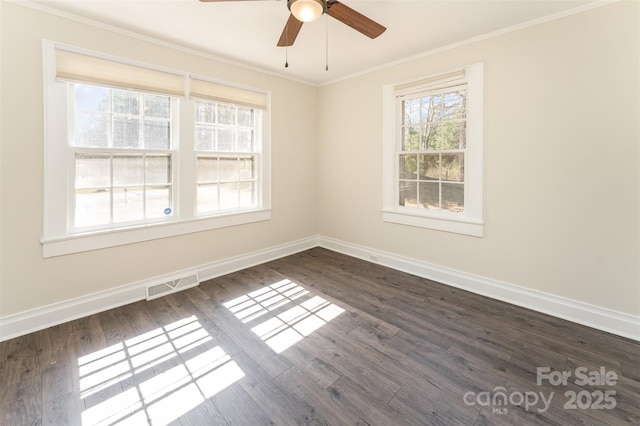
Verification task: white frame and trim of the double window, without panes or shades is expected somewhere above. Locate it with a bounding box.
[40,40,271,258]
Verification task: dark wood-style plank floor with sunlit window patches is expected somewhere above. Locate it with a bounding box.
[0,248,640,426]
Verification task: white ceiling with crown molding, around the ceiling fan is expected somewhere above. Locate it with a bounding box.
[22,0,601,85]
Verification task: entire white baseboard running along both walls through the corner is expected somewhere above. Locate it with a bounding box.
[0,236,640,341]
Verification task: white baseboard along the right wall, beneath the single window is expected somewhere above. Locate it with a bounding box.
[318,236,640,341]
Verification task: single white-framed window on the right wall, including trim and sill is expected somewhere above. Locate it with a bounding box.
[382,64,483,236]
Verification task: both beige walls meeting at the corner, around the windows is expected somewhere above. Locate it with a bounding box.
[0,2,640,317]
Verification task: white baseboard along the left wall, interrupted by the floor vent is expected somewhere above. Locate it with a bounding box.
[0,237,318,342]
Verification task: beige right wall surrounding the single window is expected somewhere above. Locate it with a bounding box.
[318,2,640,315]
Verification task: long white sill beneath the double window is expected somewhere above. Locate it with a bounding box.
[40,209,271,258]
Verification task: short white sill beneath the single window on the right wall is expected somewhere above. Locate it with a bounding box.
[382,210,484,237]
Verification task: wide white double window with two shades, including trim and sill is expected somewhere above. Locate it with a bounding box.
[42,42,271,257]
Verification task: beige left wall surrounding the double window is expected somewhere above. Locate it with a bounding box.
[0,2,317,317]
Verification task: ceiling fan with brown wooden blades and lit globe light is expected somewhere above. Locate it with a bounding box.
[200,0,386,47]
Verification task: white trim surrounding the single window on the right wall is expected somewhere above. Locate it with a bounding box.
[382,64,484,237]
